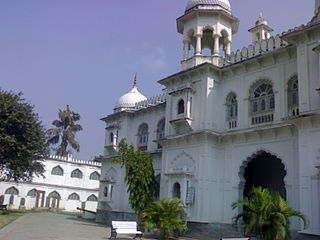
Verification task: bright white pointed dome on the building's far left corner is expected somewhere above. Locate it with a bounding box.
[115,85,147,109]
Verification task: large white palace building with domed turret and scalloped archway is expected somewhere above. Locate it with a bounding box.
[98,0,320,234]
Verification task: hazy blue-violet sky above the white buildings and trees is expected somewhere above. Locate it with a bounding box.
[0,0,314,159]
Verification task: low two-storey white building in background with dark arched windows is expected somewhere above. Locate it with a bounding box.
[0,155,101,211]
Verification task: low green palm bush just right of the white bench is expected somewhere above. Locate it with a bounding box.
[142,198,187,239]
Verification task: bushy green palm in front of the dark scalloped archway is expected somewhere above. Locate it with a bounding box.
[232,187,307,240]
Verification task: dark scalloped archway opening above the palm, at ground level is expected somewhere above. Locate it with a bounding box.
[243,152,286,200]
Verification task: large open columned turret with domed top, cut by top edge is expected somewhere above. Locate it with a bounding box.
[177,0,239,70]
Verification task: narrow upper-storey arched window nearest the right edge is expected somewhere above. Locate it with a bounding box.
[288,75,299,116]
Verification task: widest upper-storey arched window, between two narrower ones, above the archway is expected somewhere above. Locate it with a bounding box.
[250,82,275,124]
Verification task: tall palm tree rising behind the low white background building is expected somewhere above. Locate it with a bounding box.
[47,105,82,156]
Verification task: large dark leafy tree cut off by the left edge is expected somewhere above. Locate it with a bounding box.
[0,89,47,181]
